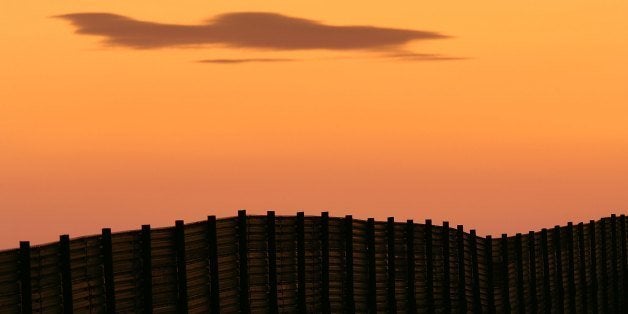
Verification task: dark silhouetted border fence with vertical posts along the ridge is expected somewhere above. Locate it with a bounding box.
[0,211,628,313]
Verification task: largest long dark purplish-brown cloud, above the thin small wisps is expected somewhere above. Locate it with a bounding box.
[58,12,447,50]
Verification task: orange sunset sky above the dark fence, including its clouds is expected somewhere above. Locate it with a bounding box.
[0,0,628,248]
